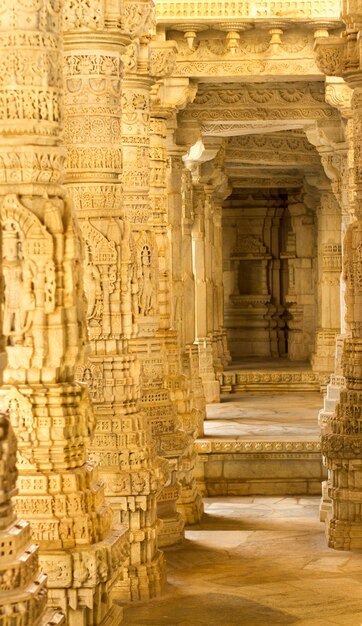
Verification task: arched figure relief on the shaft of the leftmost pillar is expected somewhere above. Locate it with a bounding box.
[1,195,56,369]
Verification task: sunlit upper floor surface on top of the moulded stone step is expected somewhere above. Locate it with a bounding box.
[204,392,323,441]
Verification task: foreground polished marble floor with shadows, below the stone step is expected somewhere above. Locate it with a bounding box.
[122,497,362,626]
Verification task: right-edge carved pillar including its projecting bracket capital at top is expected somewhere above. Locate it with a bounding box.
[316,29,362,550]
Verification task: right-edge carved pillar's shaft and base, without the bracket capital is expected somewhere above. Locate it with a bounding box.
[322,81,362,550]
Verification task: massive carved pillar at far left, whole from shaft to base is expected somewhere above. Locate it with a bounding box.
[0,0,128,626]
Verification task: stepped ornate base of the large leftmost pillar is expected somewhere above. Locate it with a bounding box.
[1,383,129,626]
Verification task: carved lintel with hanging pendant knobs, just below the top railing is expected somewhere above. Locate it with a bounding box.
[167,26,328,82]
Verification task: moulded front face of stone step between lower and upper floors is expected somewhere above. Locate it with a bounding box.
[195,438,326,496]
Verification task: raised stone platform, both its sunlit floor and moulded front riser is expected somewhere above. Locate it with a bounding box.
[196,393,326,496]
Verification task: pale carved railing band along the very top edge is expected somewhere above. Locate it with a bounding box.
[156,0,341,23]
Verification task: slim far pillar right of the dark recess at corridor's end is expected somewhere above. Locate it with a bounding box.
[312,189,342,375]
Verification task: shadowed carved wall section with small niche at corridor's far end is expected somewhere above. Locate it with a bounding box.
[223,189,285,359]
